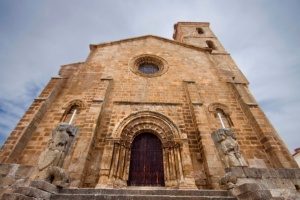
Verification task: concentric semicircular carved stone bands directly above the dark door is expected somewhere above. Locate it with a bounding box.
[112,111,181,143]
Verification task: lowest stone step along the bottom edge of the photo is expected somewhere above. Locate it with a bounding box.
[51,194,237,200]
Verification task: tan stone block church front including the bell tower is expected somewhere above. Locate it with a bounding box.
[0,22,298,200]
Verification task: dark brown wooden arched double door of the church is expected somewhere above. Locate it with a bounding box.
[128,133,165,186]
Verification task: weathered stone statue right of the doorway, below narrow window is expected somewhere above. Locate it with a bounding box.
[212,128,247,168]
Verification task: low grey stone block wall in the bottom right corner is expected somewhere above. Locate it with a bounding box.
[227,167,300,200]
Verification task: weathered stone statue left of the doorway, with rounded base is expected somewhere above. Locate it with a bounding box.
[35,123,74,187]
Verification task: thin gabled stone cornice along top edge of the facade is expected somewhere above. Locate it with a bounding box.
[90,35,212,53]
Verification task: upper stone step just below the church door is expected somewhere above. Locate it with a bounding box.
[60,188,232,197]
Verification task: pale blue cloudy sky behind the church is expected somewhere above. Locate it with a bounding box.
[0,0,300,153]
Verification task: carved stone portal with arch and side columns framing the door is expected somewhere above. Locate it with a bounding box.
[96,111,196,188]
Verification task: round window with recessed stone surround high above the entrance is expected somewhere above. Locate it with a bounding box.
[129,55,168,77]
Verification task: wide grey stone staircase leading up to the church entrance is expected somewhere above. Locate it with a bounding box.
[51,187,237,200]
